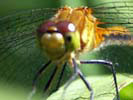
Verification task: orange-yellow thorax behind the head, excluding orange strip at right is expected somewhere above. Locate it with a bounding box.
[54,7,96,51]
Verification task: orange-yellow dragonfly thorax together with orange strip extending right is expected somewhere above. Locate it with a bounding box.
[53,7,129,52]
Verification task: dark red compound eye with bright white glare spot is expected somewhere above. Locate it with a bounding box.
[57,21,75,34]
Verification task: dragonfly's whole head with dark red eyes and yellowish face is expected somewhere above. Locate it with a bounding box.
[37,21,80,59]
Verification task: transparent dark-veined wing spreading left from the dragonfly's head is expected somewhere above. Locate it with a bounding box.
[0,9,55,59]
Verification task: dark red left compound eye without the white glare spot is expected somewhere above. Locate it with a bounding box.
[37,20,55,37]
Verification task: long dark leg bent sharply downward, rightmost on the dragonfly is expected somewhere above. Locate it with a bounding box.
[80,60,120,100]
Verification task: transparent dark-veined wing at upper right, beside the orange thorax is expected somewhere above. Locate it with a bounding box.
[92,0,133,33]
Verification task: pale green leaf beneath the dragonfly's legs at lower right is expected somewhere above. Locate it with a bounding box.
[47,74,133,100]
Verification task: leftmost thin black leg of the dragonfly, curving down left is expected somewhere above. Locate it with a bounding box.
[32,61,51,89]
